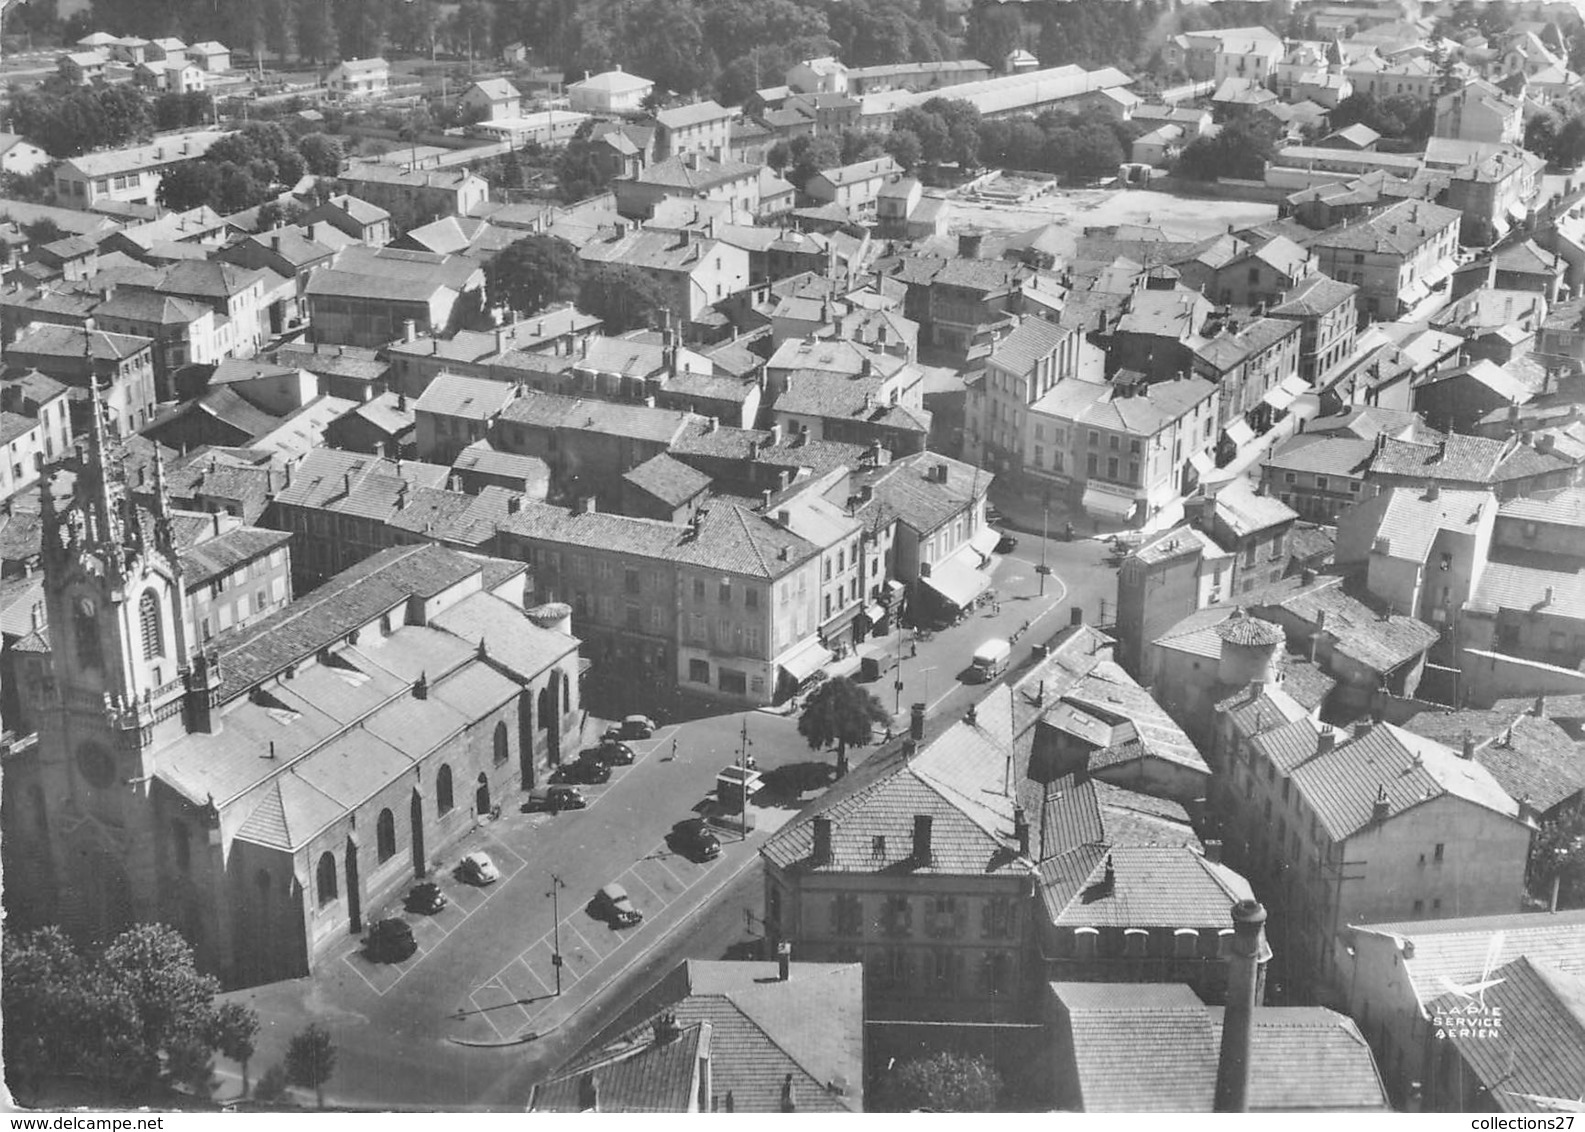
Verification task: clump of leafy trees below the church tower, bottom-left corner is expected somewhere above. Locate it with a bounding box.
[0,924,257,1100]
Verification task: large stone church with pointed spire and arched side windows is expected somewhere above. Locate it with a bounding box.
[0,388,580,986]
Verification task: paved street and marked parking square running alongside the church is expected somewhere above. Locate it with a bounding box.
[216,536,1116,1110]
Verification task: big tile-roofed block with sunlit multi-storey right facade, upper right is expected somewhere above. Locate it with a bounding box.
[1311,201,1460,319]
